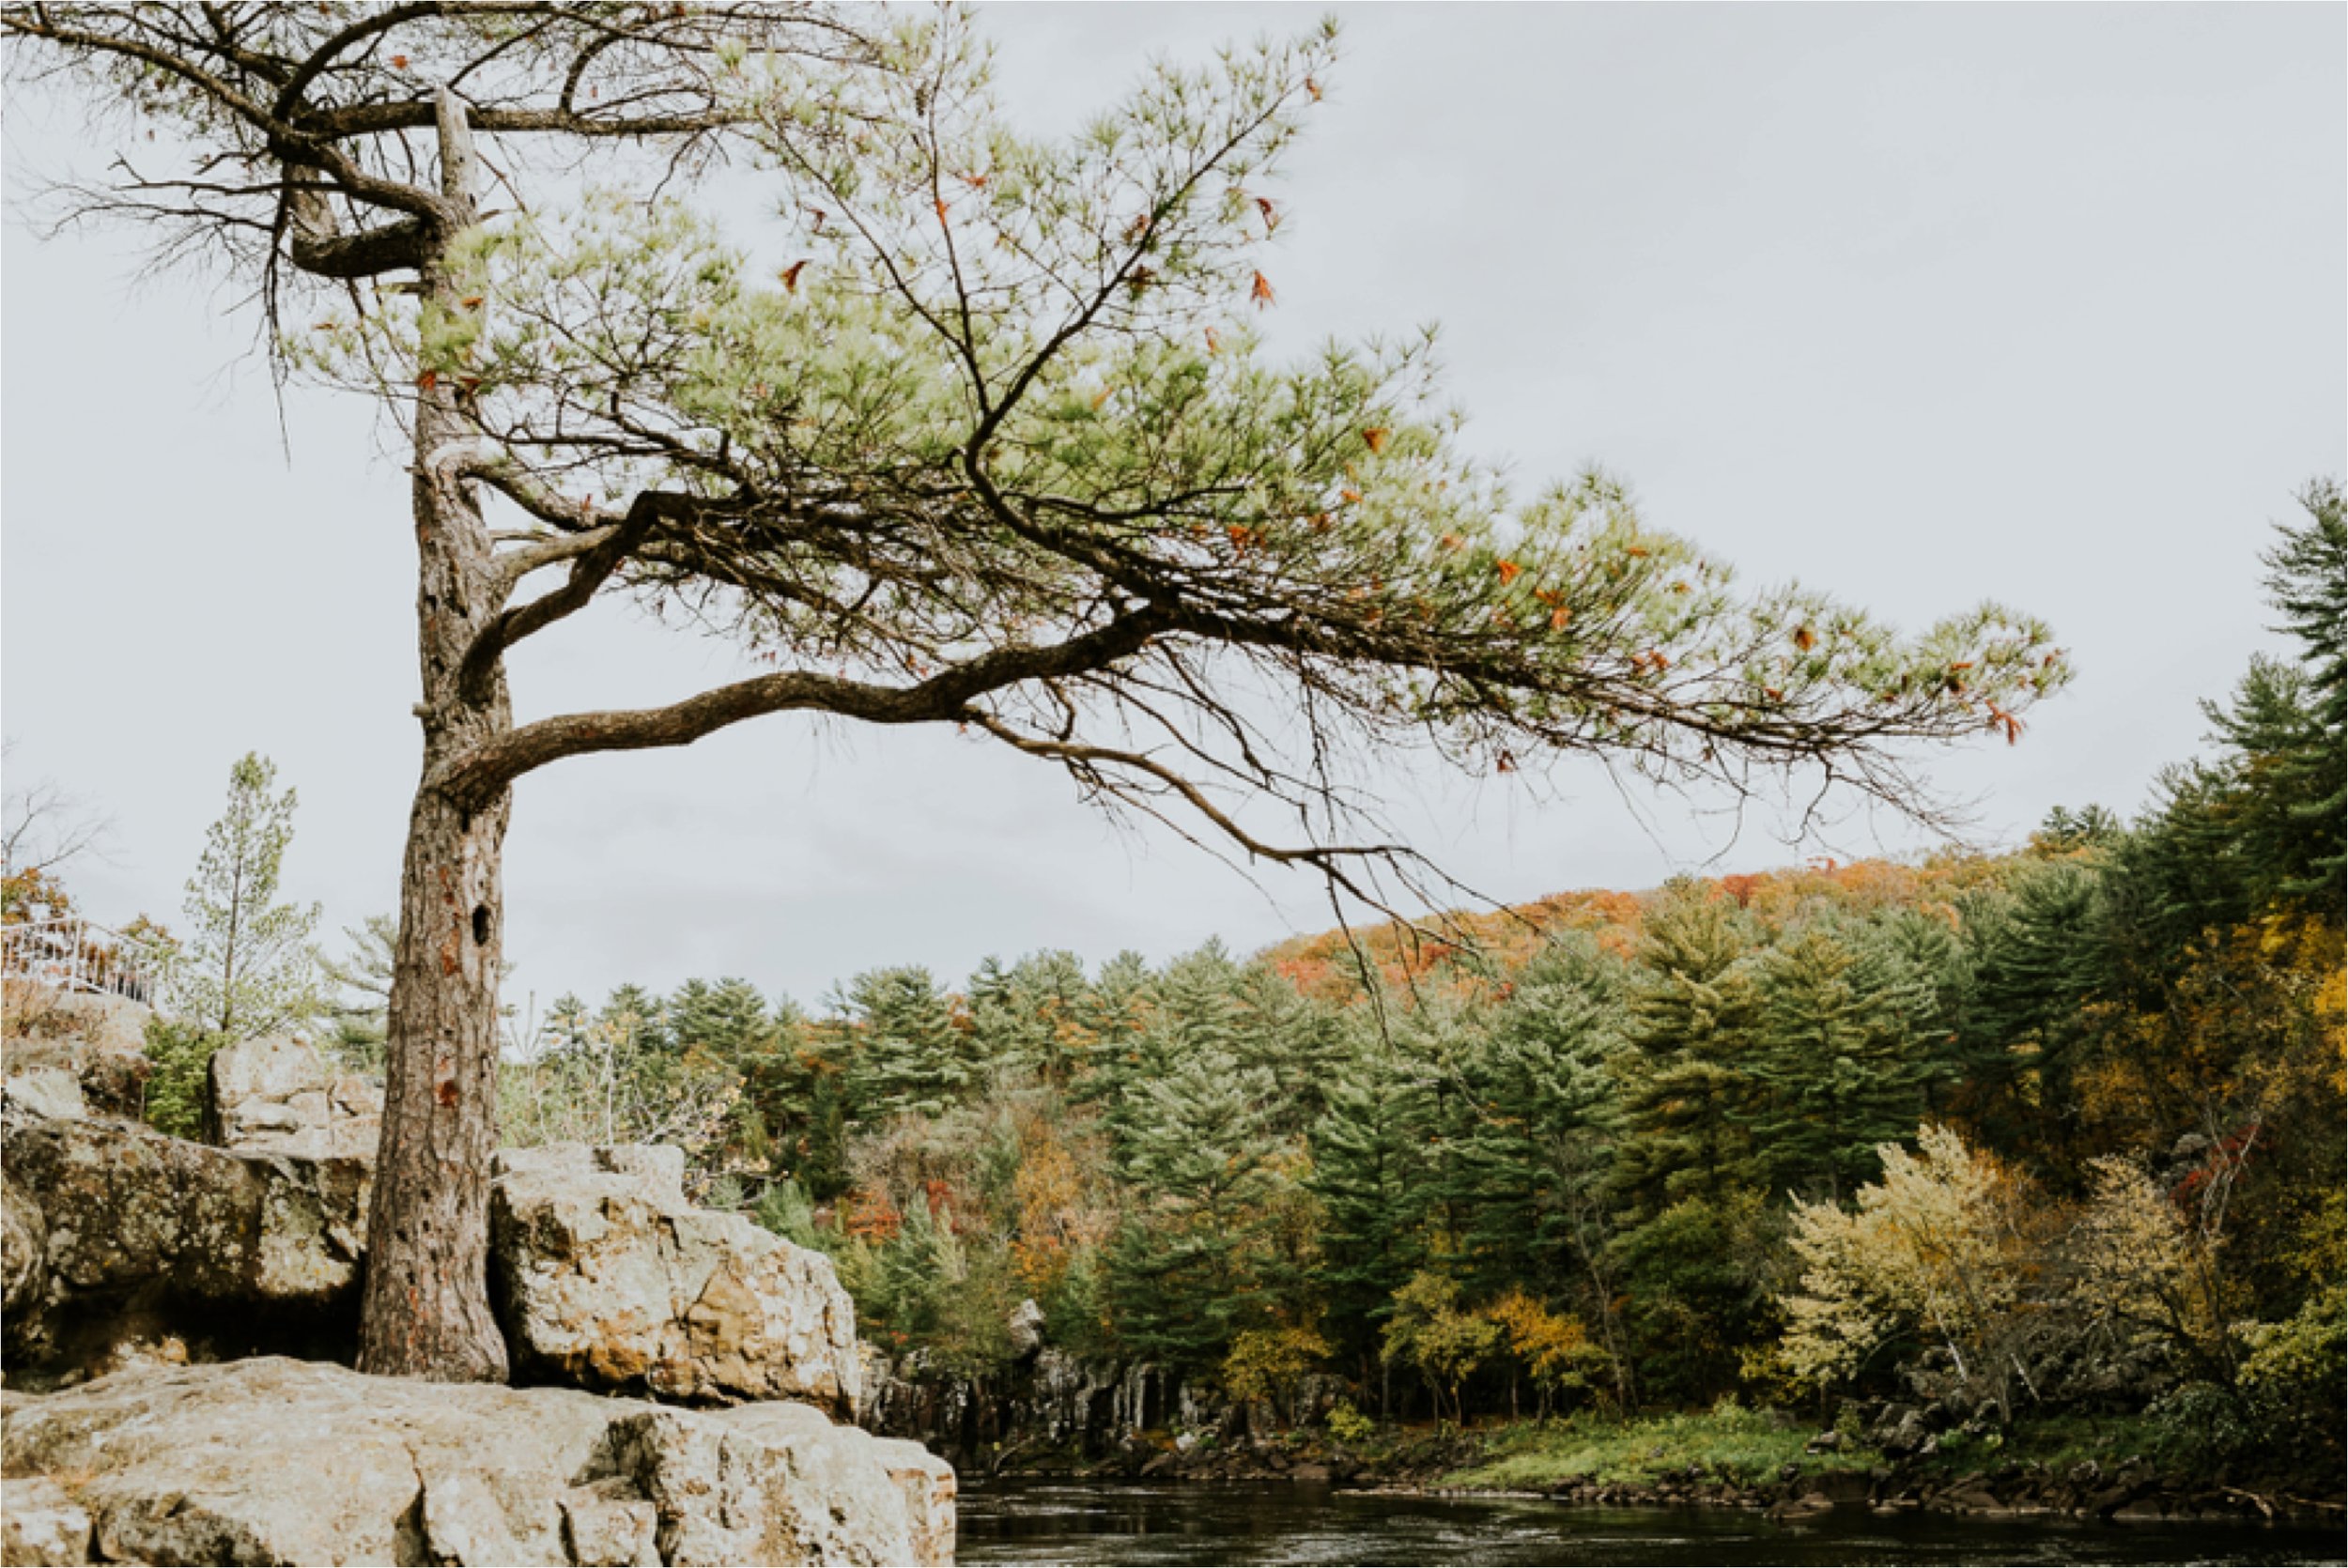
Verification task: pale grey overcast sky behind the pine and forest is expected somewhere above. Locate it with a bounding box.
[0,5,2348,1003]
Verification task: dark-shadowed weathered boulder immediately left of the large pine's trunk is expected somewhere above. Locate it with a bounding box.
[0,1108,369,1388]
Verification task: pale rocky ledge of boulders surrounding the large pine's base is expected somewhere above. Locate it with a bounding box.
[0,1000,956,1563]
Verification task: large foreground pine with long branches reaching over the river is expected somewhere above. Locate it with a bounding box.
[13,0,2064,1378]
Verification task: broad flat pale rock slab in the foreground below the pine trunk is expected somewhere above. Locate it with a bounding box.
[0,1360,956,1563]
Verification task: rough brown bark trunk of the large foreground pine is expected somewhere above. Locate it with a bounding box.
[360,94,515,1383]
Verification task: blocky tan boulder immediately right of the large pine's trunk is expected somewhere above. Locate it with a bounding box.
[488,1144,862,1421]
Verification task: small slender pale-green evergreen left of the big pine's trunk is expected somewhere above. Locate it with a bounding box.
[172,754,319,1045]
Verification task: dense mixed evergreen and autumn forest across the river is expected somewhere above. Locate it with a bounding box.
[448,482,2348,1477]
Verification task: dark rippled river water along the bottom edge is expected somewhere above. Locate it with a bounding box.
[958,1482,2343,1568]
